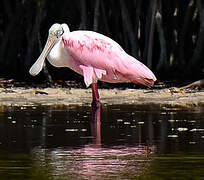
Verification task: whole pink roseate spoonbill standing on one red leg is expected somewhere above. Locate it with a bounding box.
[29,24,156,102]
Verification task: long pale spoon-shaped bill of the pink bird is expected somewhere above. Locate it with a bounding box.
[29,36,56,76]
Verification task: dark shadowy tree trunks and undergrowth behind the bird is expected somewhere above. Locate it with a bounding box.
[0,0,204,84]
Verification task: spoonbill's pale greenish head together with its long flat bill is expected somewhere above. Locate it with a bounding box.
[29,23,70,76]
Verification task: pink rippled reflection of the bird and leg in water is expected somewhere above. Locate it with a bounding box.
[25,105,155,179]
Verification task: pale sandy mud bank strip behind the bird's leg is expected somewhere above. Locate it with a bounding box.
[0,88,204,108]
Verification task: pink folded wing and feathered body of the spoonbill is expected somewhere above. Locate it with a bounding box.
[63,31,156,86]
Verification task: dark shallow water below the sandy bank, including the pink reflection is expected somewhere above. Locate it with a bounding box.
[0,105,204,180]
